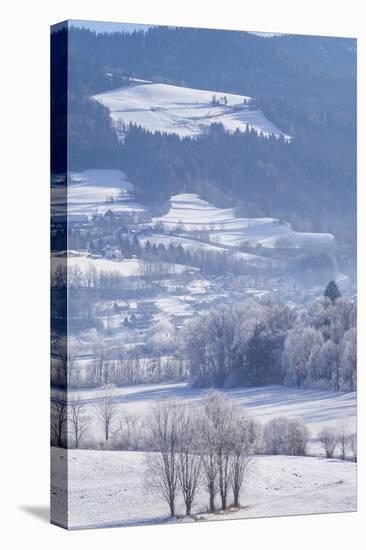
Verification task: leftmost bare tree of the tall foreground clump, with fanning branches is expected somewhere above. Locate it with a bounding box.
[146,401,179,517]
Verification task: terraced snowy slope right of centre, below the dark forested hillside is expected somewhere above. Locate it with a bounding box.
[153,193,334,248]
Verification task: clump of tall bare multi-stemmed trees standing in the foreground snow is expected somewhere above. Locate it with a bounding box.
[147,392,259,516]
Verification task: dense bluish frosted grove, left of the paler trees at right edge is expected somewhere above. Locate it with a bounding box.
[182,299,297,387]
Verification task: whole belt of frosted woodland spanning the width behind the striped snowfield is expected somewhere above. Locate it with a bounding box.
[52,282,357,391]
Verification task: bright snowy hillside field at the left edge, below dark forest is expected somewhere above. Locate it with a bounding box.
[52,169,145,215]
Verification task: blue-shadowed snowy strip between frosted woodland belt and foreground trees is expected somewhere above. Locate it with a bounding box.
[53,384,356,453]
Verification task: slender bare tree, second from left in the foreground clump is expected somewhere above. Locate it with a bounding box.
[178,406,201,516]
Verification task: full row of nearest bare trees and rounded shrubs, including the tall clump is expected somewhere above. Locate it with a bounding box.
[51,390,357,468]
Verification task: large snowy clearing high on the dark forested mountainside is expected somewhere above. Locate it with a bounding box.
[93,83,290,140]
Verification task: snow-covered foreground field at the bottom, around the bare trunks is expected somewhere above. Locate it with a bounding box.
[52,448,356,528]
